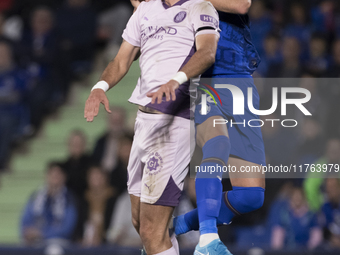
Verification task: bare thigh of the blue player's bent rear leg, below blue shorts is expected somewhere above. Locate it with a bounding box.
[228,157,266,188]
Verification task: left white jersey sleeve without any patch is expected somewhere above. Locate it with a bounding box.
[122,4,142,47]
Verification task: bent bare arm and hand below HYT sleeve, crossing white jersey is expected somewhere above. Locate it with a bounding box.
[147,34,219,104]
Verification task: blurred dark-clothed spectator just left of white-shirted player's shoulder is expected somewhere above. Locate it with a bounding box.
[95,0,133,61]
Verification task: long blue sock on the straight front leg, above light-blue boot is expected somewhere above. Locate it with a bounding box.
[196,136,231,235]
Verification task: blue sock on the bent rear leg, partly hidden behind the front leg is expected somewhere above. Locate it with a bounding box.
[174,187,265,235]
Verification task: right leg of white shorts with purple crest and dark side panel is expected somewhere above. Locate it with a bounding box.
[141,113,195,206]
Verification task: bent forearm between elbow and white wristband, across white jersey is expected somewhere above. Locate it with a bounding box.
[180,48,216,79]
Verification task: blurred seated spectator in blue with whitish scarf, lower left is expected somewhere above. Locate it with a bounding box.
[21,163,77,245]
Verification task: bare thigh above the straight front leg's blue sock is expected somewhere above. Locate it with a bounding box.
[196,116,229,148]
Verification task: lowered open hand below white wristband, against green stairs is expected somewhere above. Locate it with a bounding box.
[84,89,111,122]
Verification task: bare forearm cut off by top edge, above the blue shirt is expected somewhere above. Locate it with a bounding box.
[209,0,251,14]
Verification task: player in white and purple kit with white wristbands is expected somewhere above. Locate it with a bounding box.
[84,0,219,255]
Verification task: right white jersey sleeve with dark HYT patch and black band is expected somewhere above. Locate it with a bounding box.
[191,1,221,36]
